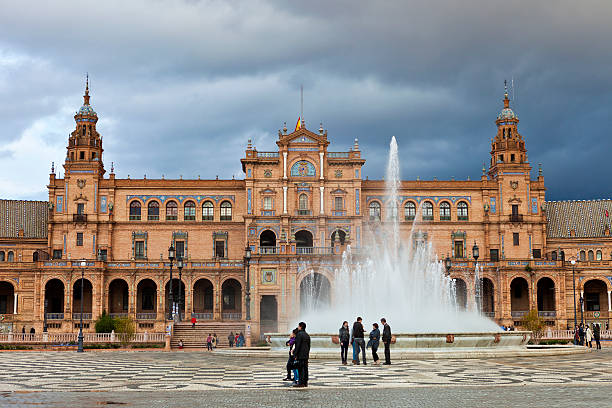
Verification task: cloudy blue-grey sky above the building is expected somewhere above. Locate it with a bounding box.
[0,0,612,200]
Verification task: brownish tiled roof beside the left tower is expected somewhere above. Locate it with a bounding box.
[0,200,49,238]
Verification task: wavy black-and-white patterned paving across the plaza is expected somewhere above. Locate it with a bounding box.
[0,350,612,391]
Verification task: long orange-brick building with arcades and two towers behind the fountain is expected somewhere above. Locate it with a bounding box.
[0,83,612,336]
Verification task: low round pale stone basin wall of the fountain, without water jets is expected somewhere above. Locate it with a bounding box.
[265,331,531,359]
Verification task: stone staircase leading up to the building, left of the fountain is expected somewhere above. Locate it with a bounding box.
[170,322,246,349]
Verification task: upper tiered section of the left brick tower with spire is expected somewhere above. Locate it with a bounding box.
[64,77,105,176]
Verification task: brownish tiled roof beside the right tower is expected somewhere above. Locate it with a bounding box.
[546,200,612,238]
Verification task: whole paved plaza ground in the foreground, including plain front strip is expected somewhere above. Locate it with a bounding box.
[0,350,612,408]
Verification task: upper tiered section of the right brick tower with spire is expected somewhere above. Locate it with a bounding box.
[489,81,531,178]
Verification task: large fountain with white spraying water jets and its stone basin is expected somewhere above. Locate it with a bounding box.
[269,137,530,353]
